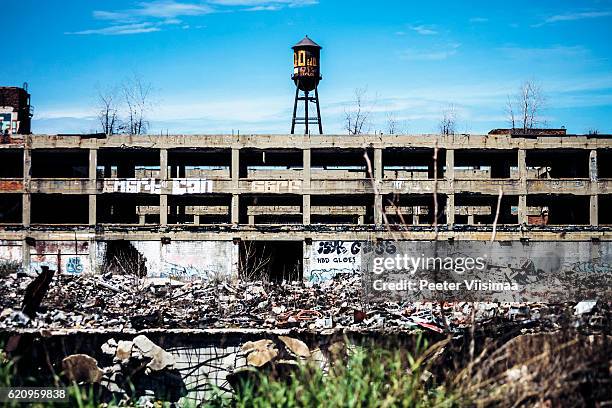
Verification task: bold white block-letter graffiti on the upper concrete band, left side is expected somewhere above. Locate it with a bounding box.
[102,178,213,195]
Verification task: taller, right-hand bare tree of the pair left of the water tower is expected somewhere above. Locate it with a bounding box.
[121,75,152,135]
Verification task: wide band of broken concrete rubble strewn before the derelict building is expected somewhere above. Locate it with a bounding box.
[0,273,610,333]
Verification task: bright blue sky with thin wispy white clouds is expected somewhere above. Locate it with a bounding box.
[0,0,612,133]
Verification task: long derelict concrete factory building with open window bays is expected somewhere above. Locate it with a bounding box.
[0,131,612,279]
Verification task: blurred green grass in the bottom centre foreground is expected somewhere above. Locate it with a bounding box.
[209,336,461,408]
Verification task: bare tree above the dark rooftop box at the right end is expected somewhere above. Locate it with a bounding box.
[506,81,545,133]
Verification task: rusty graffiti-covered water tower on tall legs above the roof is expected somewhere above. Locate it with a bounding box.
[291,36,323,134]
